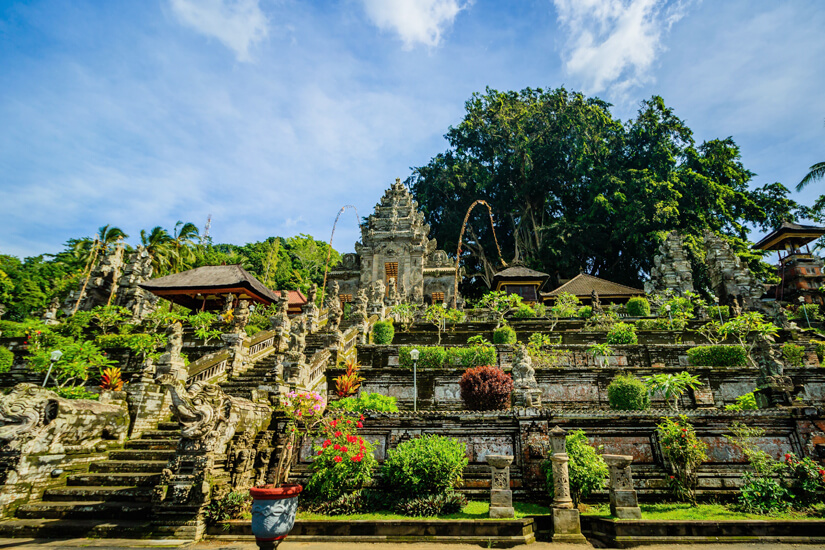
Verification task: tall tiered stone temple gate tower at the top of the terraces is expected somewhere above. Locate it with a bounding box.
[329,179,455,303]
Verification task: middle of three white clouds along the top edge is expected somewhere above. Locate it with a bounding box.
[361,0,473,49]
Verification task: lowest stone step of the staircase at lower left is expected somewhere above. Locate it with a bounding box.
[0,519,151,539]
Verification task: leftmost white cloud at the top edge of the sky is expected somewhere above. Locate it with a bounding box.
[170,0,268,61]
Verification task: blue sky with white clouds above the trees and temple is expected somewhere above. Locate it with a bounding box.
[0,0,825,257]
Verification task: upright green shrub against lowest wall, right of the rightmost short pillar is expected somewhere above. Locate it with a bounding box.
[656,416,708,503]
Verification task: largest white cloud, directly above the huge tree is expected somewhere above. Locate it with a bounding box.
[553,0,686,95]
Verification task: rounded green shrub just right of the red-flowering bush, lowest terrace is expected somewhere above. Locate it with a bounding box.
[382,435,468,498]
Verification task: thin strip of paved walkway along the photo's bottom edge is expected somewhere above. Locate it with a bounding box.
[0,539,819,550]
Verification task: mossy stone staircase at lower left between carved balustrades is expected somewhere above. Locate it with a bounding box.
[0,422,180,538]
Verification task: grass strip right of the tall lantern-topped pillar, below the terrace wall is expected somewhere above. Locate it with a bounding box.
[582,503,825,521]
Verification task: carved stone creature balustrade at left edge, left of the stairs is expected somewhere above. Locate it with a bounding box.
[0,384,129,458]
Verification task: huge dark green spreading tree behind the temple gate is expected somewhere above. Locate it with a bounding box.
[408,88,798,294]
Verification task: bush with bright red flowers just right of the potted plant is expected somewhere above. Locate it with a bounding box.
[306,416,378,501]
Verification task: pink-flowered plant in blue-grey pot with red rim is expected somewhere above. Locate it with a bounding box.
[249,391,326,550]
